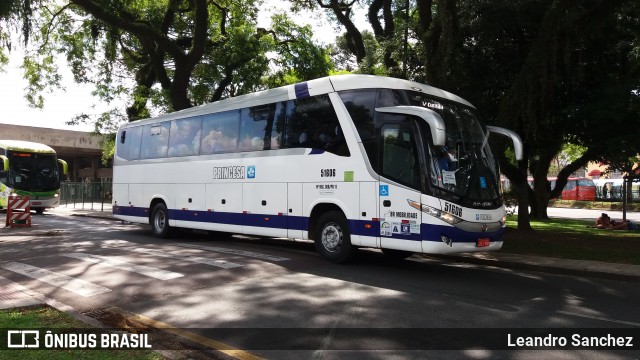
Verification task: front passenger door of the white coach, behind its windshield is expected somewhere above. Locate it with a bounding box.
[378,122,422,252]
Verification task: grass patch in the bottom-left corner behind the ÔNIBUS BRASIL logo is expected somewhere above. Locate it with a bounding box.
[0,306,163,360]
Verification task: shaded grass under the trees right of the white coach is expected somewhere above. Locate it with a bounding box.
[502,215,640,265]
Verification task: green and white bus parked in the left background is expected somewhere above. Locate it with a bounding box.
[0,140,68,214]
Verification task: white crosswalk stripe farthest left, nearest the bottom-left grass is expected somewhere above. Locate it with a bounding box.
[2,262,111,297]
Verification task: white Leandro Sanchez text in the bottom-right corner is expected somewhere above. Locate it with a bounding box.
[507,333,635,349]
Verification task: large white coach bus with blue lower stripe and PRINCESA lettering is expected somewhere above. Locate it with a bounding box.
[113,75,522,262]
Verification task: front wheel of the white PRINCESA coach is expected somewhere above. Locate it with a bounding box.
[315,211,355,264]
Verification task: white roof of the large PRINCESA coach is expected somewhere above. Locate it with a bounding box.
[122,74,473,128]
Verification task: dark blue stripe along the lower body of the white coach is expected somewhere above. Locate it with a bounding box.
[113,206,505,243]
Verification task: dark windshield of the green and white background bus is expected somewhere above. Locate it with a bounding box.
[7,150,60,191]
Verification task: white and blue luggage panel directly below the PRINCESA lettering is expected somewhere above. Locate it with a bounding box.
[205,183,242,233]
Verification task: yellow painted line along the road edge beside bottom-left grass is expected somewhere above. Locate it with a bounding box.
[106,307,263,360]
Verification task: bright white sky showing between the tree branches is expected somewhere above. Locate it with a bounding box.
[0,0,368,132]
